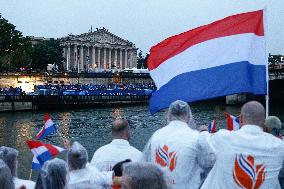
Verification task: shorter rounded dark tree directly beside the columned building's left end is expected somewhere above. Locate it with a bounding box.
[31,39,64,71]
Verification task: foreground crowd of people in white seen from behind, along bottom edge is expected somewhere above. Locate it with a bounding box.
[0,100,284,189]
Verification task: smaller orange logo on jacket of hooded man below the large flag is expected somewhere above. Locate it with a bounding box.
[156,145,177,171]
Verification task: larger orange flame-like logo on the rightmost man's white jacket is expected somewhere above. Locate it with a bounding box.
[233,154,265,189]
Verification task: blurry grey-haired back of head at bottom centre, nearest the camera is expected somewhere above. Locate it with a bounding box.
[121,162,167,189]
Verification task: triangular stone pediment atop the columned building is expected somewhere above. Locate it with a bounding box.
[62,28,135,47]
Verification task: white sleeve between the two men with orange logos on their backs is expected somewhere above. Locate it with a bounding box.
[197,131,216,169]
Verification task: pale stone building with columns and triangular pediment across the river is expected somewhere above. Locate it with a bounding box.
[60,28,137,73]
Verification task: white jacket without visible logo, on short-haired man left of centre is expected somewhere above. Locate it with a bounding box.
[90,139,141,171]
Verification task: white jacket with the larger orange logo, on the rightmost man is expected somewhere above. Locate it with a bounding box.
[201,125,284,189]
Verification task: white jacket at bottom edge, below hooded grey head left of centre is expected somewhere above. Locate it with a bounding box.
[69,166,113,189]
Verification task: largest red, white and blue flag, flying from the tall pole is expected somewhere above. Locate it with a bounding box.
[147,10,268,114]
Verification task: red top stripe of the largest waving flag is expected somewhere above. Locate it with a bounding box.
[147,10,264,70]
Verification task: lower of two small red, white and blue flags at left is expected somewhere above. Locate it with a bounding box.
[26,140,64,169]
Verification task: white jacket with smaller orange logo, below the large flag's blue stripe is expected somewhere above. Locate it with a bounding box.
[143,121,204,189]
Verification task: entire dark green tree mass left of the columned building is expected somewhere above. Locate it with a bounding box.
[0,14,64,71]
